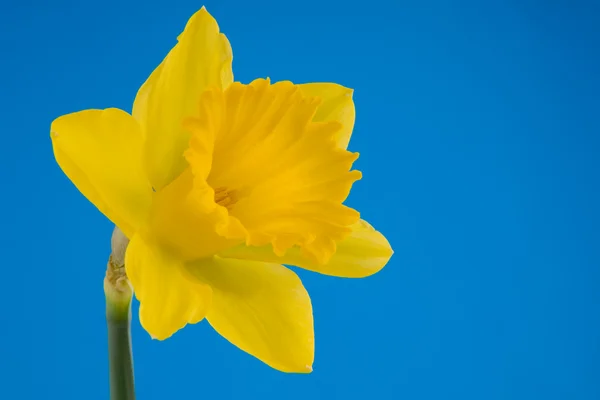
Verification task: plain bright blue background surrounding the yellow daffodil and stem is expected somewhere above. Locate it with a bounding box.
[0,0,600,400]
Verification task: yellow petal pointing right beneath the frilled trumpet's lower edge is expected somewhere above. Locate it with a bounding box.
[220,220,394,278]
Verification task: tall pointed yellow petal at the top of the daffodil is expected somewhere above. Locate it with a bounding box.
[133,8,233,190]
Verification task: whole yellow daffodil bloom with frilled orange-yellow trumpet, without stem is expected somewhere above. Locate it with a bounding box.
[51,8,392,372]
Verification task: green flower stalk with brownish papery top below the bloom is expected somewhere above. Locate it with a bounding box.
[104,228,135,400]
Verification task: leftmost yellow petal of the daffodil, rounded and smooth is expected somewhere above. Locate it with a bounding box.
[50,108,152,237]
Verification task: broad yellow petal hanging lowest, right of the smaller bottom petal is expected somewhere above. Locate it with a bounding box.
[188,257,315,372]
